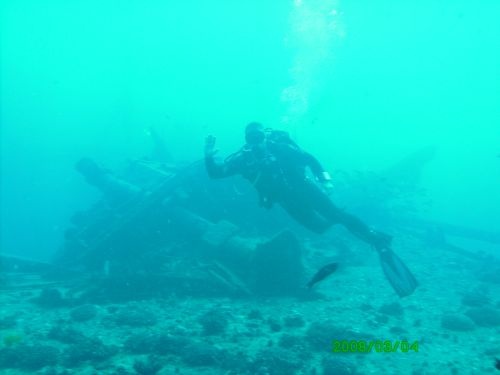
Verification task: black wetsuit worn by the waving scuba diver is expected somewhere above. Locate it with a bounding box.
[205,131,381,246]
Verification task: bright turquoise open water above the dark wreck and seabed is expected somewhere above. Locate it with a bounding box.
[0,0,500,374]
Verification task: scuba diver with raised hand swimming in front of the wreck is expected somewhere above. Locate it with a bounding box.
[205,122,418,297]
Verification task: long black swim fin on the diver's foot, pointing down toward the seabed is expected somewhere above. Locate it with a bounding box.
[378,249,418,297]
